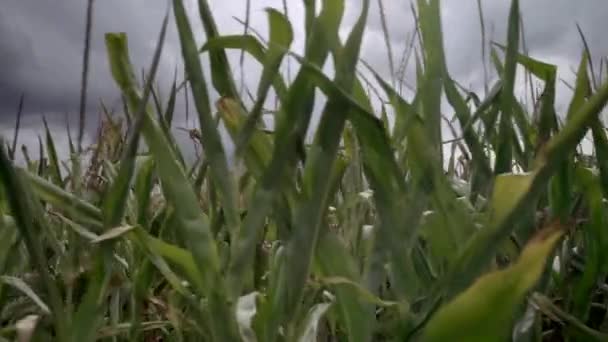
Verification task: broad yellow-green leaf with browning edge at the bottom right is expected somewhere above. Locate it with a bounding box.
[422,225,563,342]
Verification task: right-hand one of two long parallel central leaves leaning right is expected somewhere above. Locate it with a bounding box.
[277,1,369,320]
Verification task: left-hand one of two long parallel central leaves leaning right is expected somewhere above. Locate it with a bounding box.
[228,0,344,304]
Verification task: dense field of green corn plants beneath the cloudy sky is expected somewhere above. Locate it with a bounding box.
[0,0,608,342]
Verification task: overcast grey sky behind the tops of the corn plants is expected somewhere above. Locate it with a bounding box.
[0,0,608,161]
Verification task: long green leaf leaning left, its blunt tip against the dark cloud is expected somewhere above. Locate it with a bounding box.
[106,30,236,340]
